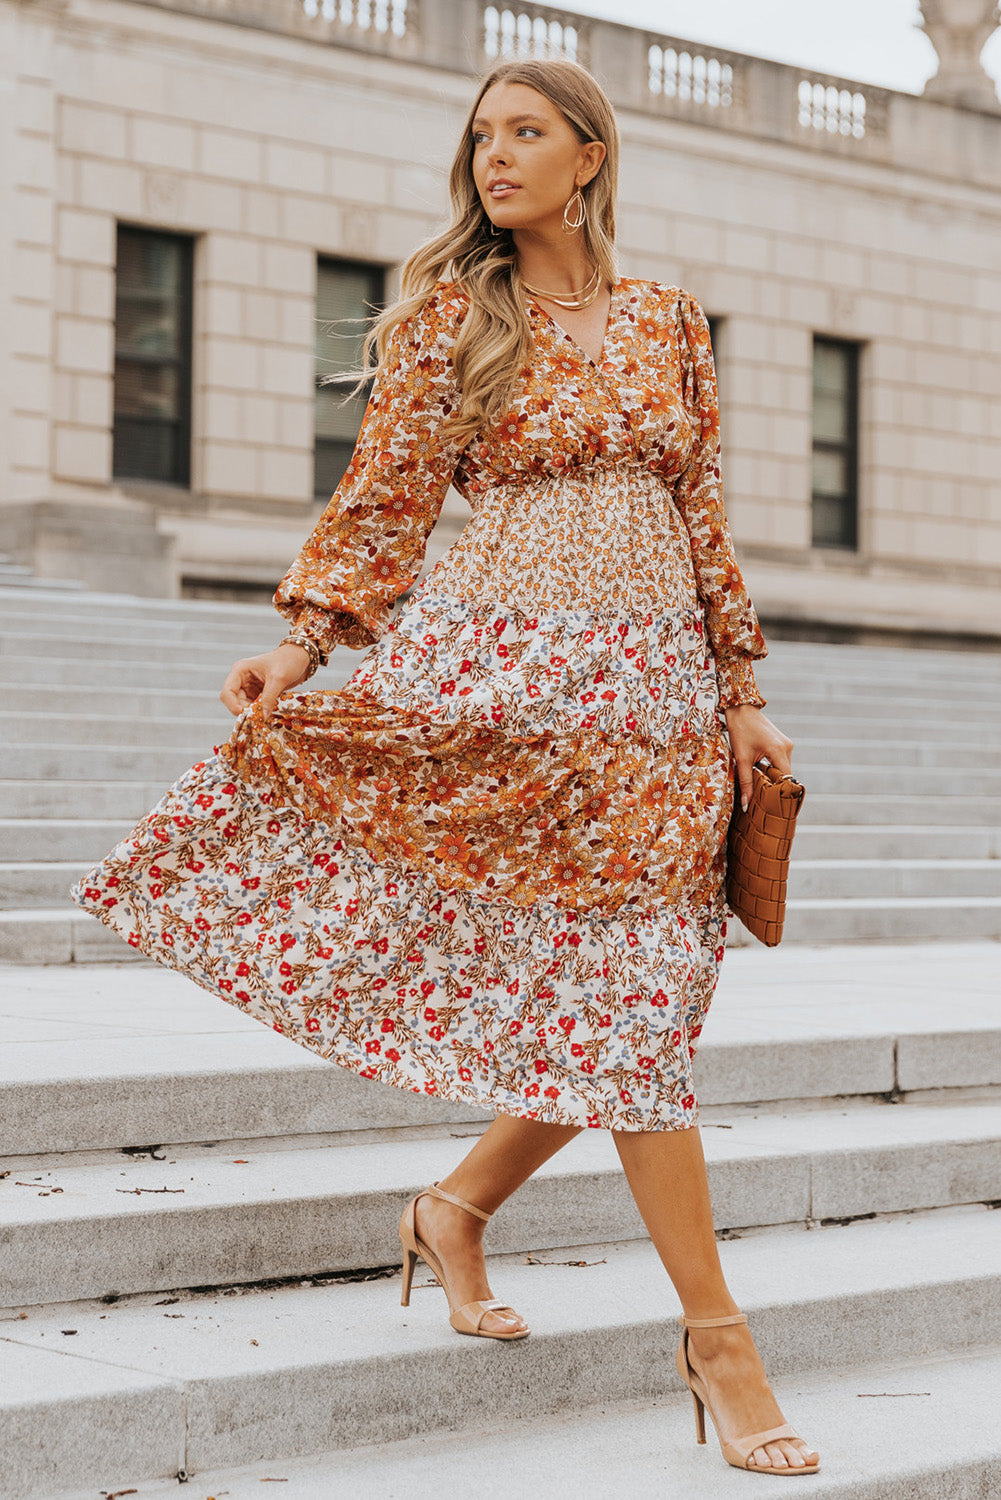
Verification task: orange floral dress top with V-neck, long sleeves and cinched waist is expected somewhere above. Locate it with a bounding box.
[275,279,767,707]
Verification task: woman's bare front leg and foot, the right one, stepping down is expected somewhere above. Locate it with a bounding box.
[612,1128,818,1469]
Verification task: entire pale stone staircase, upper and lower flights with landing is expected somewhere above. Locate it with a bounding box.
[0,587,1001,1500]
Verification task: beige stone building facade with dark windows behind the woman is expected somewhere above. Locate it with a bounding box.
[0,0,1001,645]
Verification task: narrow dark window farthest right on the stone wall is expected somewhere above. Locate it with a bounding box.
[812,338,858,548]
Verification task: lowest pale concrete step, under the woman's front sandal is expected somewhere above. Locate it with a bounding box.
[78,1349,1001,1500]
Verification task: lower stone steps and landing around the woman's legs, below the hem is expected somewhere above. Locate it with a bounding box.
[0,942,1001,1500]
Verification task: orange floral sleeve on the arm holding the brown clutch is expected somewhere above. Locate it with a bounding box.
[674,291,768,708]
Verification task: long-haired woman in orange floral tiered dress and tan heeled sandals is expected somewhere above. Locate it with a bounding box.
[74,62,816,1475]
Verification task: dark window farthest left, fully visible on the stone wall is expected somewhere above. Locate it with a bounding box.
[114,225,192,485]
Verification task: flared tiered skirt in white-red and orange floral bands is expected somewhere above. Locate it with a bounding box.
[72,576,732,1131]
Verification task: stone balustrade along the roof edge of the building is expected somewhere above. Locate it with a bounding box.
[123,0,1001,189]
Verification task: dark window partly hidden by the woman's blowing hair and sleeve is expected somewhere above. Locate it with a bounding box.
[314,257,386,500]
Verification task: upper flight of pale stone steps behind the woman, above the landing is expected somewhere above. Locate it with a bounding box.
[0,584,1001,963]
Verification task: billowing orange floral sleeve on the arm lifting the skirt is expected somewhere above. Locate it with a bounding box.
[275,288,462,651]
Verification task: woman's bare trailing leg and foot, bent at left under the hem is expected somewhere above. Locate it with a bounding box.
[416,1115,579,1331]
